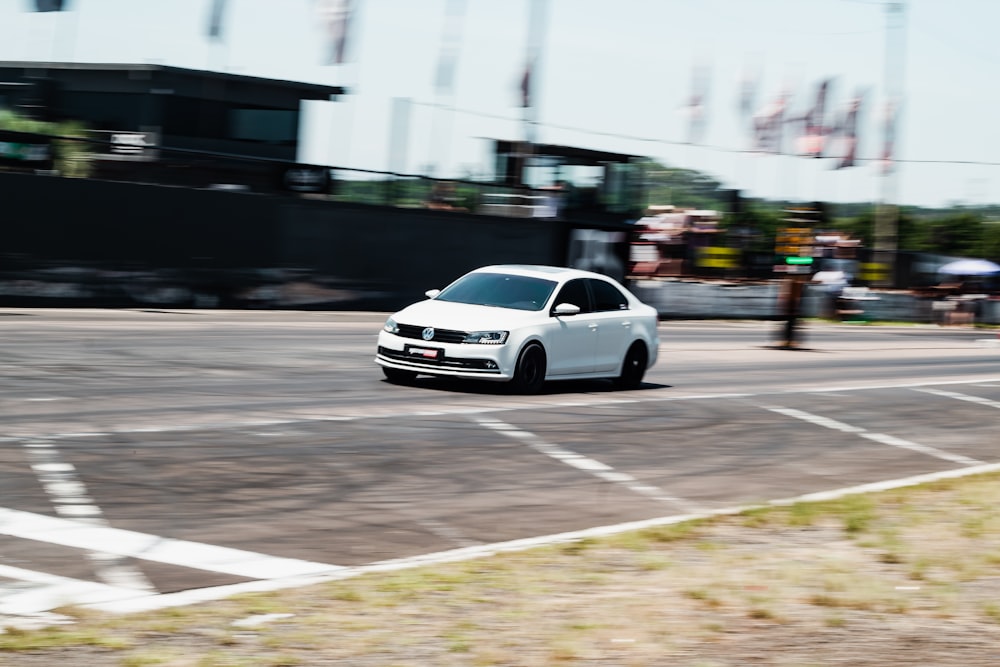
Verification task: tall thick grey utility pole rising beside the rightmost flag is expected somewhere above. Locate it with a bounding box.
[874,0,905,287]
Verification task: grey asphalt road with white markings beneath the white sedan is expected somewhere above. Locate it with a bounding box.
[0,310,1000,620]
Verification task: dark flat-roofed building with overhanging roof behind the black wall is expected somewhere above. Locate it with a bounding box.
[0,62,344,190]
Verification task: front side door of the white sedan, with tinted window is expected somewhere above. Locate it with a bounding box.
[545,279,597,375]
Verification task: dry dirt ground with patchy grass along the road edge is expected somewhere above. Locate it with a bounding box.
[0,475,1000,667]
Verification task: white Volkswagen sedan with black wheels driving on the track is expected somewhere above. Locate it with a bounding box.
[375,265,659,393]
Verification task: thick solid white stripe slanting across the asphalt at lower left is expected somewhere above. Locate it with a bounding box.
[0,508,341,579]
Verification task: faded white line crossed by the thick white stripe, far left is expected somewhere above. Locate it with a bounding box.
[21,439,155,591]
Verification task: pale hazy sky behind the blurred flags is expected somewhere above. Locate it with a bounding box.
[0,0,1000,207]
